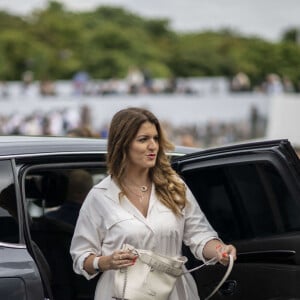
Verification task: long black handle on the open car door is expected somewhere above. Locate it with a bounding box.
[237,250,296,262]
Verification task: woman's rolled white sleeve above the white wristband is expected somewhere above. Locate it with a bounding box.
[70,192,104,279]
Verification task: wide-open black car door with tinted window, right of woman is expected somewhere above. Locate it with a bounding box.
[173,140,300,300]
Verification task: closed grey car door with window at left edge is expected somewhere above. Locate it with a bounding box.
[0,160,44,300]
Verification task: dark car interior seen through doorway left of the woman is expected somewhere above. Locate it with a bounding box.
[25,167,105,300]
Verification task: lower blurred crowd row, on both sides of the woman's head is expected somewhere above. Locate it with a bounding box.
[0,105,266,147]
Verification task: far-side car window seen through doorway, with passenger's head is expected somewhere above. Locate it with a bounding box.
[25,166,106,219]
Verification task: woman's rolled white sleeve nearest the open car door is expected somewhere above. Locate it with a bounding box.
[183,187,220,262]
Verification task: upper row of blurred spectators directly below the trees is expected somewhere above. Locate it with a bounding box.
[0,67,300,98]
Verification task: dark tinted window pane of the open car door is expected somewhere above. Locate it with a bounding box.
[185,162,300,241]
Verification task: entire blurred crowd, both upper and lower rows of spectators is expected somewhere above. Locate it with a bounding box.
[0,67,278,147]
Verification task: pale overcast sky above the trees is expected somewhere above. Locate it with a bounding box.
[0,0,300,41]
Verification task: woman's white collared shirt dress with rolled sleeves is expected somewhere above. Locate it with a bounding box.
[70,176,218,300]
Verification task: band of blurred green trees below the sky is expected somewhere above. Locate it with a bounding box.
[0,1,300,89]
